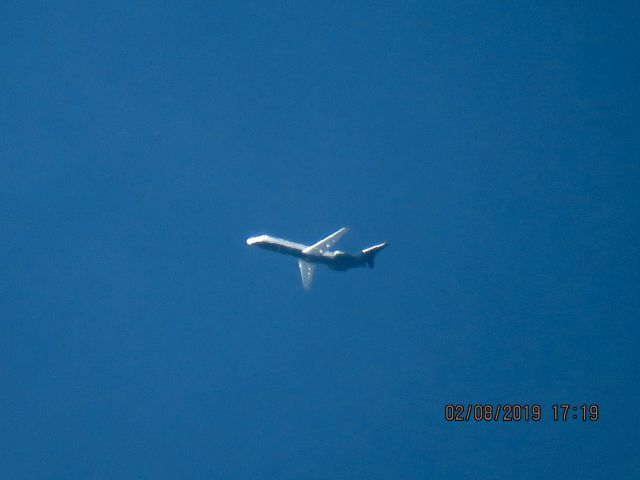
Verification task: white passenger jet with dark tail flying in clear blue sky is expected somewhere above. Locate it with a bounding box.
[247,228,389,290]
